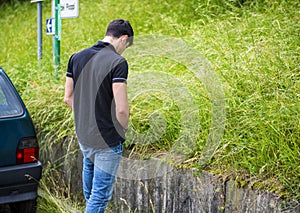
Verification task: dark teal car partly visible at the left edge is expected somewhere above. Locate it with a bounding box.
[0,68,42,213]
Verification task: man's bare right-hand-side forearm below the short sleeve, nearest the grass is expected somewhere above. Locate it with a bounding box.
[112,82,129,131]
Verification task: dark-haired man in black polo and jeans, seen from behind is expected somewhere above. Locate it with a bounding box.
[64,19,134,213]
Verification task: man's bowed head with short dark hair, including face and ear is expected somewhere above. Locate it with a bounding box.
[105,19,134,54]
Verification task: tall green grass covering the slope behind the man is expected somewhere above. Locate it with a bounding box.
[0,0,300,211]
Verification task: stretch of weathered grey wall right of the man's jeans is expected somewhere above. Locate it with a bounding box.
[113,169,300,213]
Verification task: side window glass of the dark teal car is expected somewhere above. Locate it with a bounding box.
[0,74,23,118]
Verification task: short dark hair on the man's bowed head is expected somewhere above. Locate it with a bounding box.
[105,19,134,46]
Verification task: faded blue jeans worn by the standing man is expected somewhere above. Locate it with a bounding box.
[80,144,123,213]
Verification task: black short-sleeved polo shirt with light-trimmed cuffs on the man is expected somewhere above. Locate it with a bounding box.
[67,41,128,148]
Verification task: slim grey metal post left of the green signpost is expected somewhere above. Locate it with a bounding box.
[31,0,43,61]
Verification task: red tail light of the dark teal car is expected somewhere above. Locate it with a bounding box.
[16,137,39,164]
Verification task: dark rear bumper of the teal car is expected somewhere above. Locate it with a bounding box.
[0,162,42,204]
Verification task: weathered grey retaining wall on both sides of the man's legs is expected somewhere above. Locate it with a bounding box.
[42,141,300,213]
